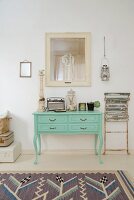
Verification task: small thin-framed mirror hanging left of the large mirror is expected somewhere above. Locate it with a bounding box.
[20,61,32,78]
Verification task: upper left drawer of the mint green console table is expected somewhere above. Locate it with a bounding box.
[38,115,67,124]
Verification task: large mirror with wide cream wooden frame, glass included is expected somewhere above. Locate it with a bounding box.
[46,33,91,86]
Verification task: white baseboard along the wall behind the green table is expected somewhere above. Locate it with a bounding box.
[22,149,134,155]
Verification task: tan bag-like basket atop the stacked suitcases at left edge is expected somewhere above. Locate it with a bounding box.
[0,117,10,134]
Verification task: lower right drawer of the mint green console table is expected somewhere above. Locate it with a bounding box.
[69,123,99,133]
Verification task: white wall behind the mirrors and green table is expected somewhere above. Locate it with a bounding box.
[0,0,134,152]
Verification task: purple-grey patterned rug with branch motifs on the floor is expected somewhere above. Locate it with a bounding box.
[0,171,134,200]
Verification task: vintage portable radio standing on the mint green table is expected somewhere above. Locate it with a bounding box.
[47,97,65,111]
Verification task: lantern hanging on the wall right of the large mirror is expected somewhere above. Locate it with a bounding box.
[101,36,110,81]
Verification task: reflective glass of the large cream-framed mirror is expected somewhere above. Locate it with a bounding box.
[50,38,85,82]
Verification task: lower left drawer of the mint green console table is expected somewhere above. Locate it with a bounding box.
[38,124,67,133]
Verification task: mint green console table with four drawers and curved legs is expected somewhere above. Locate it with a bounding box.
[33,111,103,164]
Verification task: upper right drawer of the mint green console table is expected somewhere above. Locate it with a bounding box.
[69,115,100,123]
